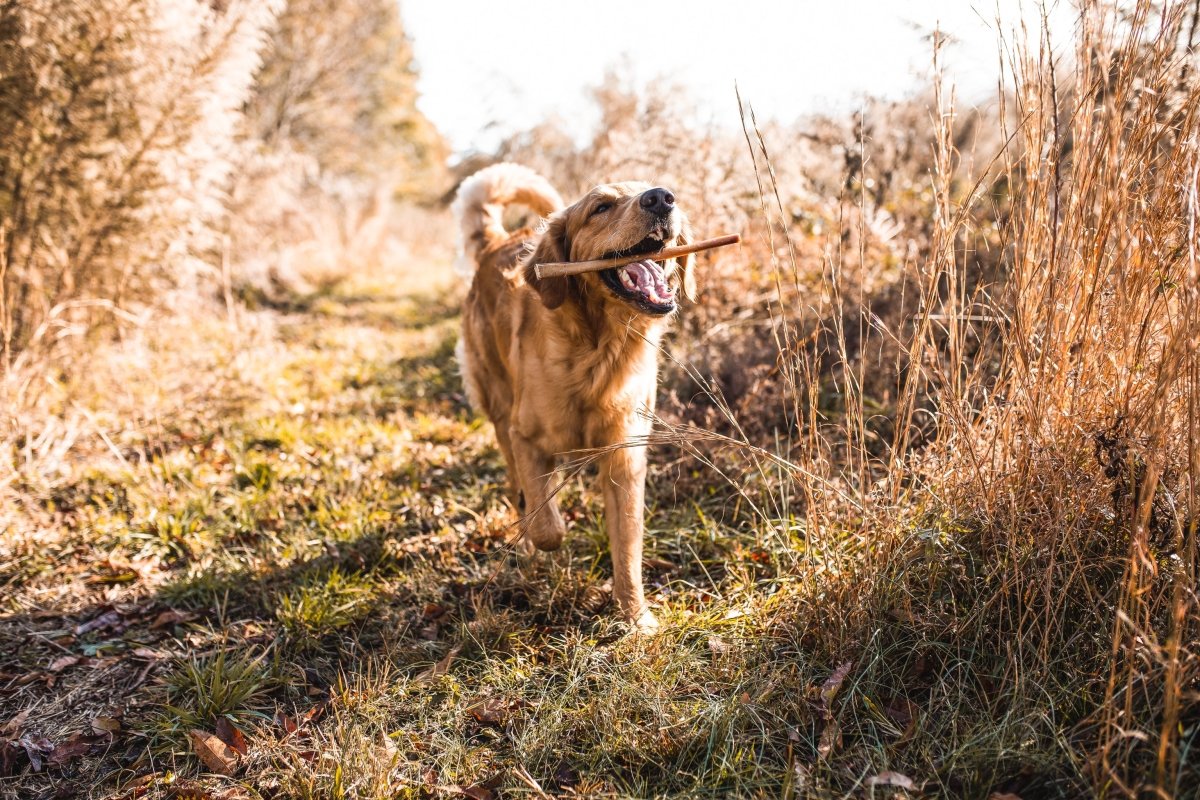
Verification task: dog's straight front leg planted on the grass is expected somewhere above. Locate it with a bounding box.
[600,447,659,630]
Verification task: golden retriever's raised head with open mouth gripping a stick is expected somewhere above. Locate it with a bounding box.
[524,182,696,317]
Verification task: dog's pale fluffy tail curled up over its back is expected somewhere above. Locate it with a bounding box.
[451,162,563,278]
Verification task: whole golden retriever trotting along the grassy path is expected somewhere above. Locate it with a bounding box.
[455,163,696,630]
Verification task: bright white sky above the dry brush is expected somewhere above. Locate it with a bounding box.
[401,0,1074,152]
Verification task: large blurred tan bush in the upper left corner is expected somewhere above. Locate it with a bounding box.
[0,0,275,366]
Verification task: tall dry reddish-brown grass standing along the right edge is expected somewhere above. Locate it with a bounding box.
[720,0,1200,796]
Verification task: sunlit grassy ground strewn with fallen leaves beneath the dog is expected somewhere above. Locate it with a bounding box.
[0,245,1128,800]
